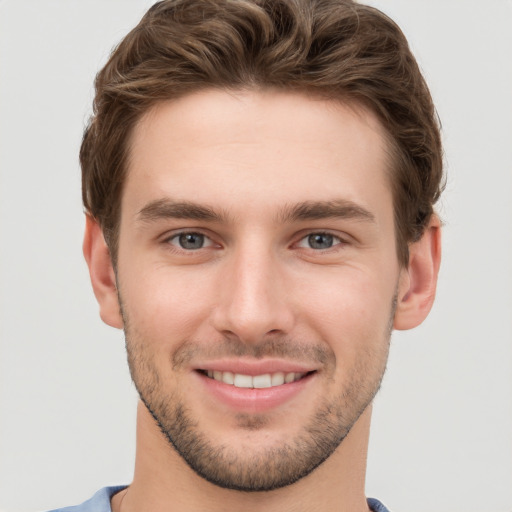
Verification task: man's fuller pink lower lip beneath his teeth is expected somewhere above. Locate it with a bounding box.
[195,372,315,413]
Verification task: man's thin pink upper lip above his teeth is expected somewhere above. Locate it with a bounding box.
[194,358,318,376]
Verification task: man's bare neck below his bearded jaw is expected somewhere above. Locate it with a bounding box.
[112,403,371,512]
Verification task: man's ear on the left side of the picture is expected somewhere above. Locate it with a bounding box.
[83,215,123,329]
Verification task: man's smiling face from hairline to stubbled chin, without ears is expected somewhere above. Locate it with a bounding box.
[117,91,400,490]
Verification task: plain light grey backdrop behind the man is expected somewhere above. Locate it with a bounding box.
[0,0,512,512]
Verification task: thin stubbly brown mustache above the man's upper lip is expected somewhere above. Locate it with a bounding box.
[172,337,336,370]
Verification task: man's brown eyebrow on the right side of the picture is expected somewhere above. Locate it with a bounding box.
[278,199,375,223]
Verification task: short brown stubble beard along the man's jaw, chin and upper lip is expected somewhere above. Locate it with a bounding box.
[123,298,396,492]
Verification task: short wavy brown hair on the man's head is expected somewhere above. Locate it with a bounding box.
[80,0,443,265]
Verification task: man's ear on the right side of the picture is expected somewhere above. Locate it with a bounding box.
[393,215,441,330]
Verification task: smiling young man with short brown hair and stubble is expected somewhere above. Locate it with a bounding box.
[53,0,442,512]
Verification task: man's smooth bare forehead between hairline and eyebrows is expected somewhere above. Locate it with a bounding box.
[122,90,391,224]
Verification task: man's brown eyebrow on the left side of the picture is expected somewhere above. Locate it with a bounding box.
[137,198,227,222]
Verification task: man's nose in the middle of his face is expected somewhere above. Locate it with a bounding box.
[213,244,294,343]
